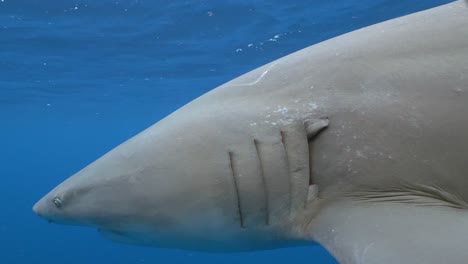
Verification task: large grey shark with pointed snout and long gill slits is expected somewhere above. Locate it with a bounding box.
[33,1,468,264]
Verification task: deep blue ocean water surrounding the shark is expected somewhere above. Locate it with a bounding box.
[0,0,450,264]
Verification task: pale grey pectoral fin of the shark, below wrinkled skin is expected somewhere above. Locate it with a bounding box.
[310,202,468,264]
